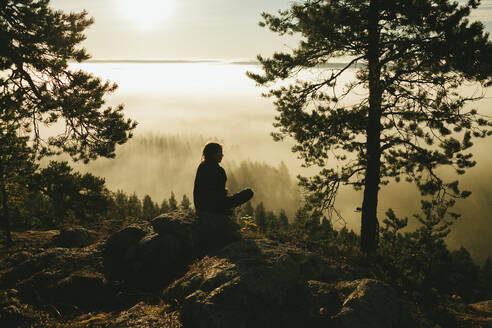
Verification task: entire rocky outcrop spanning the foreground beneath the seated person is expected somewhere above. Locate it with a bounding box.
[0,211,480,328]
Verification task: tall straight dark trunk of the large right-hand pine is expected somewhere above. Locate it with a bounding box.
[360,0,382,253]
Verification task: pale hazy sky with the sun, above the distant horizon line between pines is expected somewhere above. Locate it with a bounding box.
[51,0,492,59]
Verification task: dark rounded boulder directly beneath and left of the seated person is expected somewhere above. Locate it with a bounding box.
[104,211,240,289]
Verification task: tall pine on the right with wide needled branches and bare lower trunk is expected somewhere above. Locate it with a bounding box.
[248,0,492,252]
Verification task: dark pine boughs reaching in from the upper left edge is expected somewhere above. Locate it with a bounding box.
[0,0,136,236]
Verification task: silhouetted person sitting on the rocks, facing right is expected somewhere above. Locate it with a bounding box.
[193,142,254,215]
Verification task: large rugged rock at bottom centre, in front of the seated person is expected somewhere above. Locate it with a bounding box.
[163,239,411,328]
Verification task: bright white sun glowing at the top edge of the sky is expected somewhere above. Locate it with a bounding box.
[115,0,176,30]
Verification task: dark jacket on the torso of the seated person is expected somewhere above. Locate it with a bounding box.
[193,161,227,212]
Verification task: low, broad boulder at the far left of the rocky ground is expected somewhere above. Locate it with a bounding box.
[0,243,115,313]
